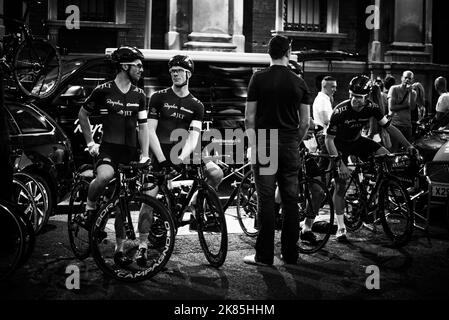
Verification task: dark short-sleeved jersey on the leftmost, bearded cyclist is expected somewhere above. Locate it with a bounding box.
[84,81,147,147]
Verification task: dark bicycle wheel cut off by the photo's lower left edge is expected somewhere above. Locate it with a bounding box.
[0,204,26,280]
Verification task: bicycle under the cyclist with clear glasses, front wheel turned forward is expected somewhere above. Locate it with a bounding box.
[149,160,228,268]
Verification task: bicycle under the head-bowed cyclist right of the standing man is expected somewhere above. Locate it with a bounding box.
[340,152,414,247]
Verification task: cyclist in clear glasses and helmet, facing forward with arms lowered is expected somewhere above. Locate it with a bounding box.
[137,55,223,264]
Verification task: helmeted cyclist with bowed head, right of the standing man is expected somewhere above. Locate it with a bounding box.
[325,76,411,241]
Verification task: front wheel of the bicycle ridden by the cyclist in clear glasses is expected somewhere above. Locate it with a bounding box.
[195,183,228,268]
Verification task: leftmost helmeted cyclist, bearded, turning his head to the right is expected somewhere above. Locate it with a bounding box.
[78,46,149,266]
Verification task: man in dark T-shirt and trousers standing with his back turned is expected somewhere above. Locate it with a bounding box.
[243,35,312,266]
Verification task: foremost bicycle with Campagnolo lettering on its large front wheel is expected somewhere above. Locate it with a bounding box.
[89,162,175,282]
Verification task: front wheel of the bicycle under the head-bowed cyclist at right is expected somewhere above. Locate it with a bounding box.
[379,177,414,247]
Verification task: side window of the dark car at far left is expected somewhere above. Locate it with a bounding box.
[8,105,53,134]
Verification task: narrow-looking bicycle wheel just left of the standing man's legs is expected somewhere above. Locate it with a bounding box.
[237,170,259,237]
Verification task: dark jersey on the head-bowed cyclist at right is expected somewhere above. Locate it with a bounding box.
[327,100,384,141]
